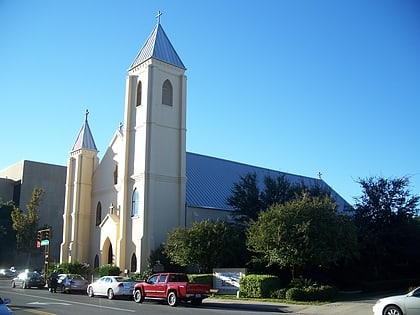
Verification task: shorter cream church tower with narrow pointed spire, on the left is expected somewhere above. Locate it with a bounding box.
[60,110,98,262]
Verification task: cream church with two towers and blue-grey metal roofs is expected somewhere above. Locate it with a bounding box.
[60,20,346,272]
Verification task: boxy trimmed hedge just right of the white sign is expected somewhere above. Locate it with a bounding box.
[239,275,280,298]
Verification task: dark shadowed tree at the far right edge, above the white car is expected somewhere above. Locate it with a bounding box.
[354,177,420,278]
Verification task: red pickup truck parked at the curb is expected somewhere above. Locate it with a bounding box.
[133,272,210,306]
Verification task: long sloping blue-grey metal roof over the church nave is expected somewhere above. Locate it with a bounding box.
[186,152,348,211]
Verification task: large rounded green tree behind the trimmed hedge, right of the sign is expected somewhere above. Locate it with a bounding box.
[247,192,356,278]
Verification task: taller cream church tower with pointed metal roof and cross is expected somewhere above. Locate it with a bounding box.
[121,13,187,270]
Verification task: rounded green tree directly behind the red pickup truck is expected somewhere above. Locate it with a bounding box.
[164,220,246,272]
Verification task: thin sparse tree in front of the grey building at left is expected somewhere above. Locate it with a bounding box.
[11,188,44,265]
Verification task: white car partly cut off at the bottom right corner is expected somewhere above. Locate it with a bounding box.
[372,287,420,315]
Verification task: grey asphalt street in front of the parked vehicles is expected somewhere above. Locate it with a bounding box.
[0,280,374,315]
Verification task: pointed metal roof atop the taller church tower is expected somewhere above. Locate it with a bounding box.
[129,24,186,69]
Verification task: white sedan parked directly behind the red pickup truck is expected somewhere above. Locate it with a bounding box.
[87,276,136,300]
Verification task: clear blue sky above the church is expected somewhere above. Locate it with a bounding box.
[0,0,420,204]
